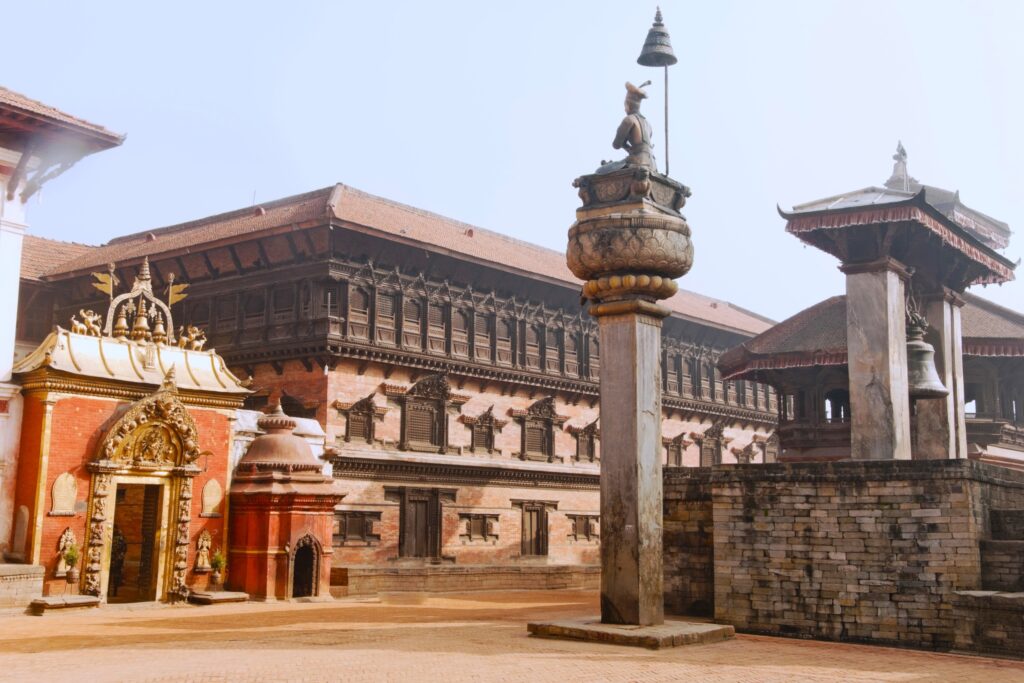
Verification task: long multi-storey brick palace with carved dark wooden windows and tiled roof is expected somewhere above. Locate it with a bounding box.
[18,185,775,589]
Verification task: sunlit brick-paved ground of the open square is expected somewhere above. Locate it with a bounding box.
[0,591,1024,683]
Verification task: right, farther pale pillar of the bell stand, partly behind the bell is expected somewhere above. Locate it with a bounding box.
[913,290,967,460]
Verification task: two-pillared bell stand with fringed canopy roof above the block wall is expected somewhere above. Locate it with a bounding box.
[779,144,1014,460]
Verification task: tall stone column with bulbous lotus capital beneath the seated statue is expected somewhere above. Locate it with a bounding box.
[567,166,693,626]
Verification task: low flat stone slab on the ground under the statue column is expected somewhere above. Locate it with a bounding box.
[526,618,736,650]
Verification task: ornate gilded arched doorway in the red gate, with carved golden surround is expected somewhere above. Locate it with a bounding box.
[82,375,201,600]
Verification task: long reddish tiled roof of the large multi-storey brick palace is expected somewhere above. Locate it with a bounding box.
[34,184,772,334]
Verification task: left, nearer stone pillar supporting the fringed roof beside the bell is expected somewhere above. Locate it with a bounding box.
[841,258,910,460]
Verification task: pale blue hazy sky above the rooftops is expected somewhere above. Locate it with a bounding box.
[0,0,1024,319]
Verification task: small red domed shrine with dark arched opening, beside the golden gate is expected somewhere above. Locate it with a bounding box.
[227,403,344,600]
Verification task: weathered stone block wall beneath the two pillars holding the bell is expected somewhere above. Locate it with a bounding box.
[665,461,1024,649]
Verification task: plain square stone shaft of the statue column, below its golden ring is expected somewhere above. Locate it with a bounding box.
[592,301,668,626]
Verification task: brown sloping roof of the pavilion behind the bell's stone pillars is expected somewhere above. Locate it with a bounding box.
[718,293,1024,379]
